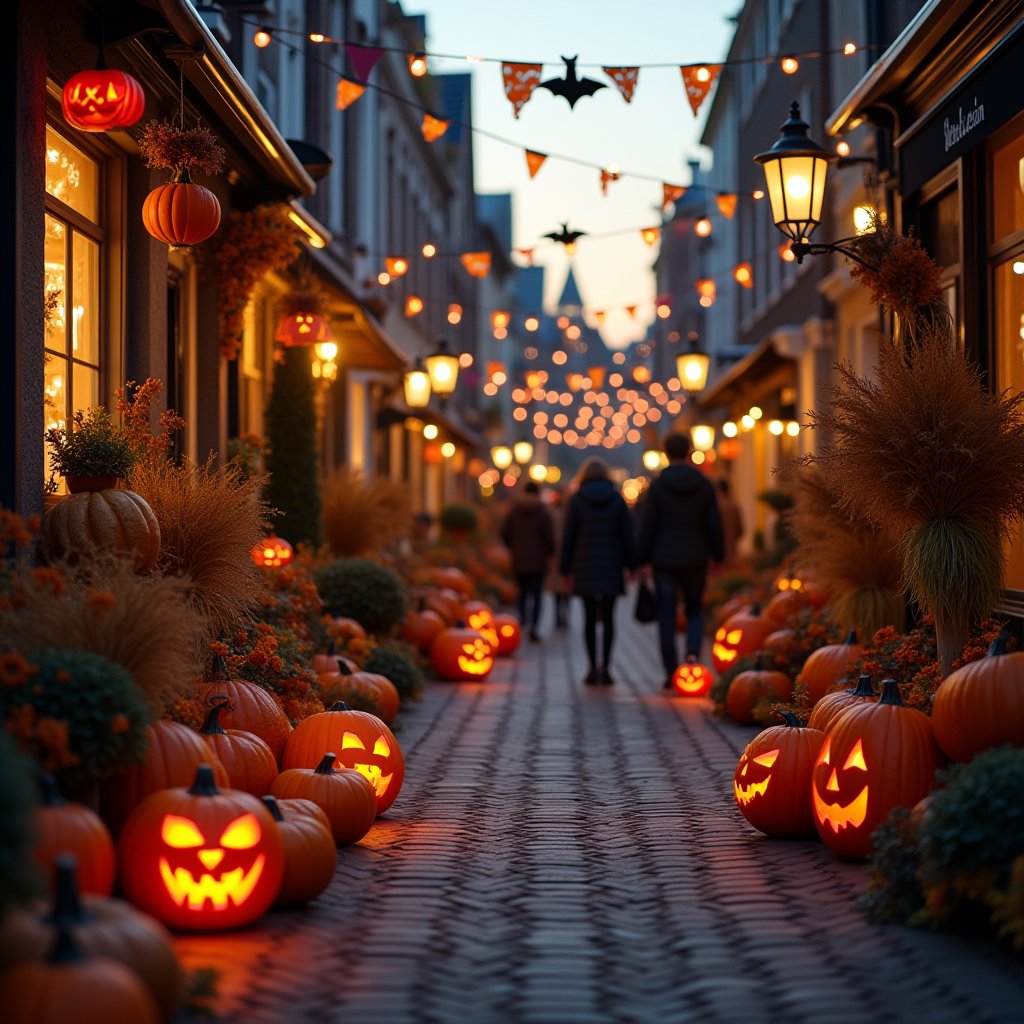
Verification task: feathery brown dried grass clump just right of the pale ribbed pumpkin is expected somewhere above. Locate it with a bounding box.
[131,456,268,634]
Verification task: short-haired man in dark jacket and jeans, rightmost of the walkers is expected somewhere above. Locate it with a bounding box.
[637,434,725,689]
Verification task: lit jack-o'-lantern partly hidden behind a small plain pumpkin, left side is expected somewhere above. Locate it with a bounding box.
[284,701,406,814]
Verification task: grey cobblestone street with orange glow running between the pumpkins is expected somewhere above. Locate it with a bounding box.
[177,600,1024,1024]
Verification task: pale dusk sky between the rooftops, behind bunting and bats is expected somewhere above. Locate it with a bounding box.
[403,0,741,347]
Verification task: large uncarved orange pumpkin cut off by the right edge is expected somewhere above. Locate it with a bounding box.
[932,637,1024,761]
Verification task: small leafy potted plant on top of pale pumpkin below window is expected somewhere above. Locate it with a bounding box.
[46,406,135,495]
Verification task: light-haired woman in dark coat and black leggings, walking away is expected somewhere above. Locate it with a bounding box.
[561,459,636,686]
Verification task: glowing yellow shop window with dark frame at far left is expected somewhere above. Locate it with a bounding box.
[43,126,104,476]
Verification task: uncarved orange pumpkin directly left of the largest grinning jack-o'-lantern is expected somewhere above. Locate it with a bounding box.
[33,773,115,896]
